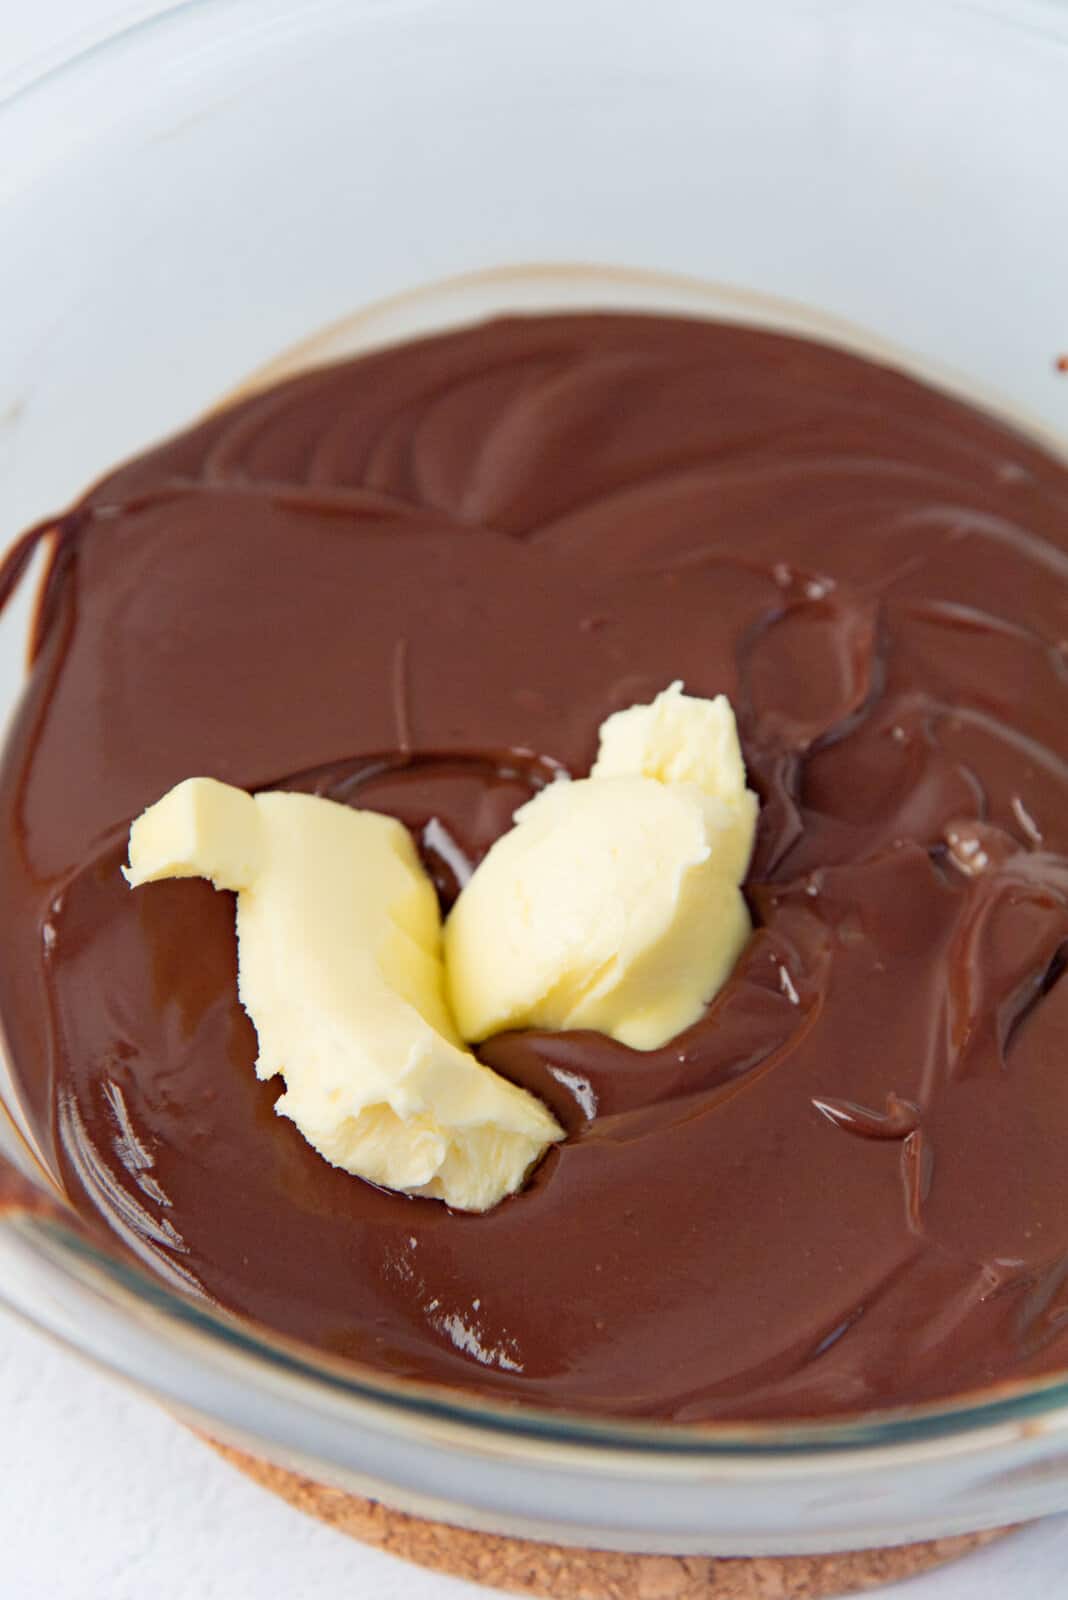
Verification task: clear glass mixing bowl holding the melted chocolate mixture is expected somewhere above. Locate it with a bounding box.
[0,0,1068,1555]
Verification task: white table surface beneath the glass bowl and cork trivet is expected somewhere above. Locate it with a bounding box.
[0,0,1068,1600]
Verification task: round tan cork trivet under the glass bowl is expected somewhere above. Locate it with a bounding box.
[208,1440,1010,1600]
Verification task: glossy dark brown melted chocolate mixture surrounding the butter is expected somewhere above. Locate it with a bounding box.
[0,315,1068,1421]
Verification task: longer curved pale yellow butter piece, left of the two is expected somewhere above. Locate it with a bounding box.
[126,778,563,1211]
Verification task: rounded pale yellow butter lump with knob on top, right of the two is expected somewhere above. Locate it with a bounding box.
[444,683,758,1050]
